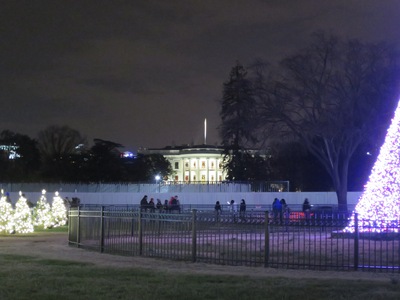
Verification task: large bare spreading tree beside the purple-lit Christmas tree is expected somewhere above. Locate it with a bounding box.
[255,33,399,209]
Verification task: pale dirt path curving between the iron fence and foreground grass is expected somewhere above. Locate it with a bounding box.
[0,233,400,281]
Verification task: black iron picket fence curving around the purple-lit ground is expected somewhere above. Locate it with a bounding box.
[69,206,400,272]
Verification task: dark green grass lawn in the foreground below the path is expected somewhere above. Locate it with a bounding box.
[0,255,400,300]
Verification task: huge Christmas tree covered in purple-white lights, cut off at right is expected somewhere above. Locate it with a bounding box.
[345,101,400,233]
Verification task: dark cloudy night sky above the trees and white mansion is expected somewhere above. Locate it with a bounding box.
[0,0,400,151]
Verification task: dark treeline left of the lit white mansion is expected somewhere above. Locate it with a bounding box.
[0,126,172,183]
